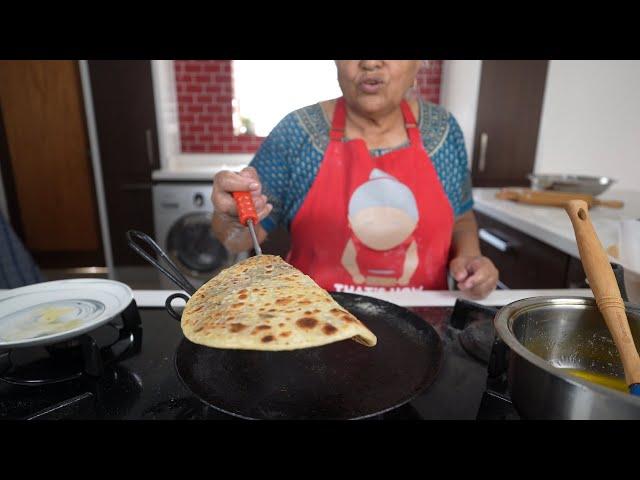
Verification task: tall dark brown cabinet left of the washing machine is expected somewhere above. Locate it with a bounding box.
[89,60,160,266]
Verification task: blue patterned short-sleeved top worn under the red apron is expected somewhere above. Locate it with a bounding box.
[251,99,473,232]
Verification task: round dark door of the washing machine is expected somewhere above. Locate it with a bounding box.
[167,212,232,281]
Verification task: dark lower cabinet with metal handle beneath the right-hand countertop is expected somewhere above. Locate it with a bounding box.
[474,212,585,289]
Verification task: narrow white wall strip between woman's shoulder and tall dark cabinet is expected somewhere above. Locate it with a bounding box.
[440,60,482,166]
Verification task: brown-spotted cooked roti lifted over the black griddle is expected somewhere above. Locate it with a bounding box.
[181,255,377,350]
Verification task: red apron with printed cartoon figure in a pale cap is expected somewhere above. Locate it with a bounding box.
[287,98,454,291]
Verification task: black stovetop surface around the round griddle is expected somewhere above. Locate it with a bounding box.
[0,304,517,420]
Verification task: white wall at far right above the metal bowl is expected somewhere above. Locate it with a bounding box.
[535,60,640,191]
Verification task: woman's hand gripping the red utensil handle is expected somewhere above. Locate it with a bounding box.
[211,167,273,224]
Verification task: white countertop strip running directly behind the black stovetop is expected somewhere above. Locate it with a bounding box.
[133,289,593,308]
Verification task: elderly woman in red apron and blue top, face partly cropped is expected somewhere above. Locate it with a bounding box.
[212,60,498,298]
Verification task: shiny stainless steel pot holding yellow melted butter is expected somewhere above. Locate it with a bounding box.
[494,297,640,420]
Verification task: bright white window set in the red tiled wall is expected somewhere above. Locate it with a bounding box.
[233,60,342,137]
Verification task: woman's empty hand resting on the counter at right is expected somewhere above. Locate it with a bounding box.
[449,256,498,299]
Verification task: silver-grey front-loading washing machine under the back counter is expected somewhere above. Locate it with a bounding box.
[153,182,248,289]
